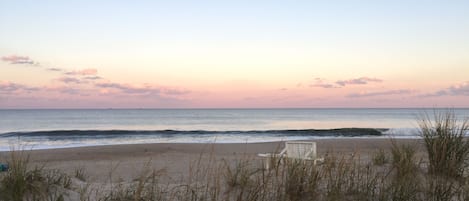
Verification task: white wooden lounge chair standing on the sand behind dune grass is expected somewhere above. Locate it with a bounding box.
[258,141,324,169]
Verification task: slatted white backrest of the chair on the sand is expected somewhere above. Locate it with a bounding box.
[285,142,317,159]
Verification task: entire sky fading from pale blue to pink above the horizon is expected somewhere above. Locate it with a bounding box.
[0,0,469,109]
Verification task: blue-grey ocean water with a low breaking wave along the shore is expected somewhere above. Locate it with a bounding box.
[0,109,469,150]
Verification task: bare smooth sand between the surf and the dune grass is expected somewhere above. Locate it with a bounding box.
[0,138,423,183]
